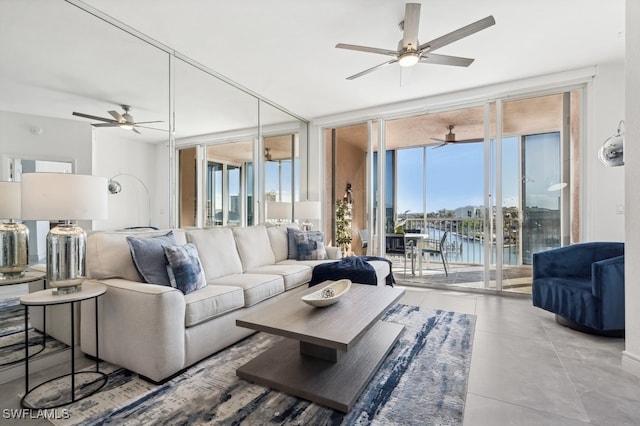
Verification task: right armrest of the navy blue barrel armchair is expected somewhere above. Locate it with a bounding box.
[591,256,624,330]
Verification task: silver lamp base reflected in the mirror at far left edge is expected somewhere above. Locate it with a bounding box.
[0,221,29,280]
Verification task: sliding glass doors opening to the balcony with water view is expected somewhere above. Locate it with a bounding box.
[327,88,581,293]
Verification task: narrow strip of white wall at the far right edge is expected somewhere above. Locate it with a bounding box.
[621,0,640,376]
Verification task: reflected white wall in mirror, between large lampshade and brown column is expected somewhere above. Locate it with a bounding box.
[93,129,168,229]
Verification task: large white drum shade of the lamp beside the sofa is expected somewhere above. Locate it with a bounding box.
[22,173,108,220]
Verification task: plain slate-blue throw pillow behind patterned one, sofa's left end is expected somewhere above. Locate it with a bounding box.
[127,231,176,287]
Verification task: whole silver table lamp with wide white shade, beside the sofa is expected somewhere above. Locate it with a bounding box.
[22,173,108,294]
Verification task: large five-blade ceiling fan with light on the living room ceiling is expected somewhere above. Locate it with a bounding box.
[336,3,496,80]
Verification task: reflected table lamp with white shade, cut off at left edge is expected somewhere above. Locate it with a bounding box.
[0,182,29,280]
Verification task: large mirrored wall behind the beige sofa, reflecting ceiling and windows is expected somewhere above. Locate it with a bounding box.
[0,0,307,380]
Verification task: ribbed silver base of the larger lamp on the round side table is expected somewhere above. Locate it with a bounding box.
[47,222,87,294]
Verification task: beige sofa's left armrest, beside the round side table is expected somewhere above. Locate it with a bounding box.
[80,279,185,381]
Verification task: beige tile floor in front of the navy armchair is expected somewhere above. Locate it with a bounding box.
[0,283,640,426]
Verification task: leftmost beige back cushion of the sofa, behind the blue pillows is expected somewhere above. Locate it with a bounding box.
[86,229,186,282]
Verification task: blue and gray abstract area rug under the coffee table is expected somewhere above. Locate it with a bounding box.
[48,305,476,425]
